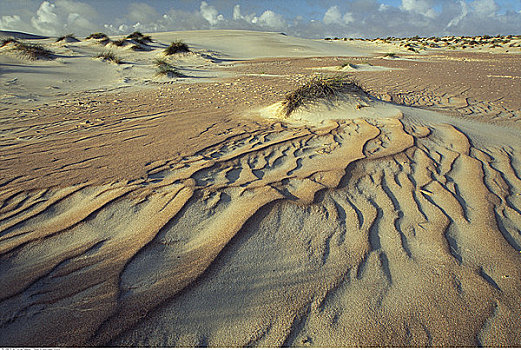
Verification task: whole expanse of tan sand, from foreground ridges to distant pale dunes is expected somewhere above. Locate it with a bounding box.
[0,31,521,347]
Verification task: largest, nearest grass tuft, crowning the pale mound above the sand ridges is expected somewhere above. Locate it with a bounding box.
[282,75,366,117]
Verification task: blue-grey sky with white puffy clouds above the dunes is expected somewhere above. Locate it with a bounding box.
[0,0,521,38]
